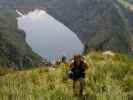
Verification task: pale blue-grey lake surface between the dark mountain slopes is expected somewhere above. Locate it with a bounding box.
[17,10,83,61]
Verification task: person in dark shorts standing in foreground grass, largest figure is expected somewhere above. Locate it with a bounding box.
[69,54,88,96]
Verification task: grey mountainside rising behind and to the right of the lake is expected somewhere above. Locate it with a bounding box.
[0,0,133,52]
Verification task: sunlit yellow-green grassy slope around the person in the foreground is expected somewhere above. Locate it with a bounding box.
[0,53,133,100]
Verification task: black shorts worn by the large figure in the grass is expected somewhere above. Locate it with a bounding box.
[69,69,85,81]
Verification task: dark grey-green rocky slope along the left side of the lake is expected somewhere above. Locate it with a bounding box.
[0,9,42,68]
